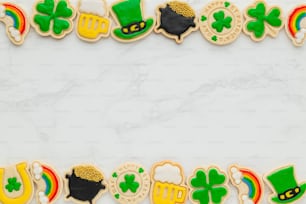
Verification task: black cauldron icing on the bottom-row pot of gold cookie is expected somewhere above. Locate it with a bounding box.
[66,170,105,204]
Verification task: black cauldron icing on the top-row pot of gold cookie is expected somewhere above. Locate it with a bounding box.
[158,4,196,39]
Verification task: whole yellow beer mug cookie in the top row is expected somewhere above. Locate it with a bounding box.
[77,0,111,42]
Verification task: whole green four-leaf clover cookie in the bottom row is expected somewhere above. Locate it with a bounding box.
[188,166,229,204]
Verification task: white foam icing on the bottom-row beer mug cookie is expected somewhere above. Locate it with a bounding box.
[154,163,183,185]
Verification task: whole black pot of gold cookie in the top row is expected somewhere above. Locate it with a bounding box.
[154,1,198,43]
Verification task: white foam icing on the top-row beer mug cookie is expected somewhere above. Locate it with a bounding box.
[79,0,106,16]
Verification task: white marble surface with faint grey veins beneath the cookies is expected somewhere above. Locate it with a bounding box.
[0,0,306,203]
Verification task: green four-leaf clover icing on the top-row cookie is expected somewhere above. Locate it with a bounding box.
[34,0,73,35]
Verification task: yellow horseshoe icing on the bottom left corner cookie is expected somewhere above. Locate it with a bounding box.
[0,162,33,204]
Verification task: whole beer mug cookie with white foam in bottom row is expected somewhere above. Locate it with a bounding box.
[150,161,188,204]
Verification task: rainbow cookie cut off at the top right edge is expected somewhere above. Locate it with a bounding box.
[286,4,306,46]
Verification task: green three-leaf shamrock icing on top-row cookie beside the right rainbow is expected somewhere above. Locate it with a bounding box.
[246,2,282,38]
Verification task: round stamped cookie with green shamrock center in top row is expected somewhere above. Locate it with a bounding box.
[199,0,243,45]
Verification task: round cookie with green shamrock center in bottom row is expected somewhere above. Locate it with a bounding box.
[109,163,150,204]
